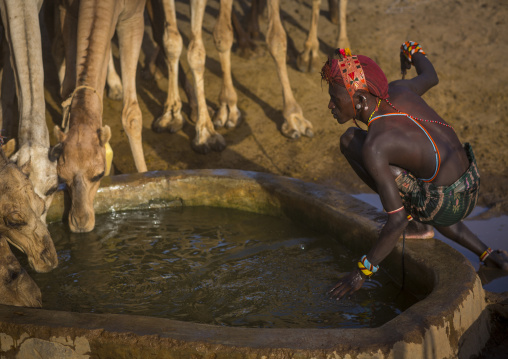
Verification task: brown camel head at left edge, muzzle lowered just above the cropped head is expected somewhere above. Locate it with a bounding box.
[0,150,58,272]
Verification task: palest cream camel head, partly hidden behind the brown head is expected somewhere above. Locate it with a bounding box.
[5,139,58,222]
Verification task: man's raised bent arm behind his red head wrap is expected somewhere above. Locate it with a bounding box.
[390,42,439,96]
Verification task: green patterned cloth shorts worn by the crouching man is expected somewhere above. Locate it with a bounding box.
[395,143,480,227]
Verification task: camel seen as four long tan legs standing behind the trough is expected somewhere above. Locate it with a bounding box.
[147,0,314,153]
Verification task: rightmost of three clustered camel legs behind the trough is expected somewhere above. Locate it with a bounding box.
[213,0,241,128]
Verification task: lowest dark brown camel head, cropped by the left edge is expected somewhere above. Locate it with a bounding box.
[0,236,42,307]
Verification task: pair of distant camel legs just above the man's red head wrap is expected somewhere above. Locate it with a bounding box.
[297,0,350,72]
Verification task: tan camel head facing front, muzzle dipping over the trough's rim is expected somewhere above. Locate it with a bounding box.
[52,124,111,233]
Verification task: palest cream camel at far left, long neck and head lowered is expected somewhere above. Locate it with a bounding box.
[0,0,58,221]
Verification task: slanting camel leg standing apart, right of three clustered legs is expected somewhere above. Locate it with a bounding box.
[266,0,314,139]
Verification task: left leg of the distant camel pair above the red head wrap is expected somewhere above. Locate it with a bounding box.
[296,0,322,72]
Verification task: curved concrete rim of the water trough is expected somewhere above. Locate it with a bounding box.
[0,170,485,355]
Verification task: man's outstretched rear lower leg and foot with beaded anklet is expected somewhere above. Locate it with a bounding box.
[435,221,508,270]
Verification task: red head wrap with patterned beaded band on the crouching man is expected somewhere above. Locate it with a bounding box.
[321,49,388,105]
